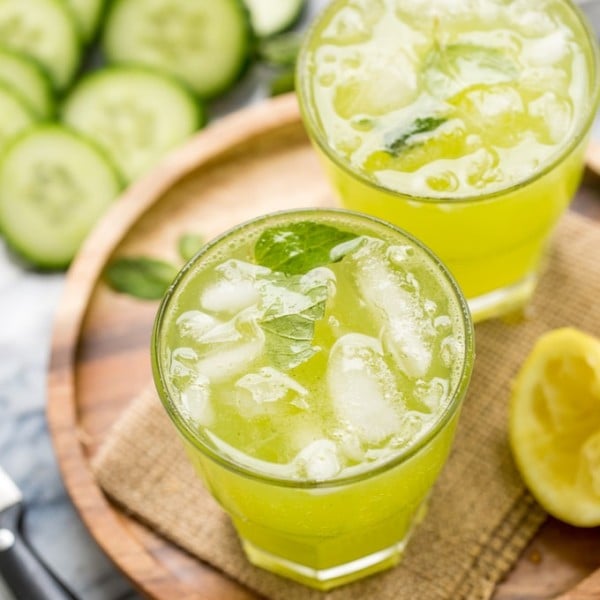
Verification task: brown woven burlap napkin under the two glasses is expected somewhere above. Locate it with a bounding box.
[94,214,600,600]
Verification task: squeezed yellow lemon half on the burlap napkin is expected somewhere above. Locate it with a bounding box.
[509,328,600,527]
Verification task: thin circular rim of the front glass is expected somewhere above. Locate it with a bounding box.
[151,208,475,489]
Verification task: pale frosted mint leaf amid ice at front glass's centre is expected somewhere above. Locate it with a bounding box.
[259,275,328,371]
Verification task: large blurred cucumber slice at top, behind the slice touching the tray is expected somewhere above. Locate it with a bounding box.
[103,0,252,98]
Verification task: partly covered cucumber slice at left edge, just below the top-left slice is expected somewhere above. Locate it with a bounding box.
[0,47,54,118]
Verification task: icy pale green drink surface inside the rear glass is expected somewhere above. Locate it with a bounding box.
[300,0,595,198]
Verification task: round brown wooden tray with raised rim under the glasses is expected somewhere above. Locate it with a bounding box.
[48,96,600,600]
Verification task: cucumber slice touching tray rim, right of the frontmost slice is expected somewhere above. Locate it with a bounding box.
[63,67,204,181]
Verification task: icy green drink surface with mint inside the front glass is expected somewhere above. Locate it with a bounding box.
[157,211,471,481]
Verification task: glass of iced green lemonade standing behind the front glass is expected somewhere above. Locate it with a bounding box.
[298,0,598,319]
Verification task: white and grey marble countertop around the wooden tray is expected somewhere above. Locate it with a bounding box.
[0,0,600,600]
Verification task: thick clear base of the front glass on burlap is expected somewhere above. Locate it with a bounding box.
[241,499,428,591]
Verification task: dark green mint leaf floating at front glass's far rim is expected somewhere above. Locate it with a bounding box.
[254,221,358,275]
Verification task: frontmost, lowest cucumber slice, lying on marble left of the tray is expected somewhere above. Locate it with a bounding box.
[0,124,121,268]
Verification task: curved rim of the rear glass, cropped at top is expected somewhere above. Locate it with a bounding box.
[295,0,600,204]
